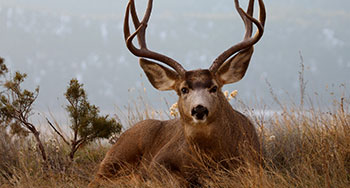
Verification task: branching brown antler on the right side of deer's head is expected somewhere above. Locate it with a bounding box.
[209,0,266,74]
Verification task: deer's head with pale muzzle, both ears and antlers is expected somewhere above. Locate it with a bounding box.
[124,0,266,125]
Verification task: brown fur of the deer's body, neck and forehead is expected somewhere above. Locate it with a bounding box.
[90,67,260,187]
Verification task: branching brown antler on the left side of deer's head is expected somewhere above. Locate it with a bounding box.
[124,0,186,76]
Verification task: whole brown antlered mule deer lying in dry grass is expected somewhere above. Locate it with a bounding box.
[90,0,266,187]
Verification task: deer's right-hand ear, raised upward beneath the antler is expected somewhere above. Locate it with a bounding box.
[216,47,254,84]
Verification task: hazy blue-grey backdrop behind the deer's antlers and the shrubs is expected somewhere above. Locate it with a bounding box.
[0,0,350,122]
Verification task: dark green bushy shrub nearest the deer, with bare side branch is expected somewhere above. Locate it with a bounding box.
[50,79,122,160]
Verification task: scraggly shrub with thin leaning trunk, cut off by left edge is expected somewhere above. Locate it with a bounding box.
[0,58,47,161]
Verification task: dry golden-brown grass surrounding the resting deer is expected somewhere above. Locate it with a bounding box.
[0,93,350,188]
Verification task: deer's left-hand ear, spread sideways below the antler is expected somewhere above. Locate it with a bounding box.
[140,58,178,91]
